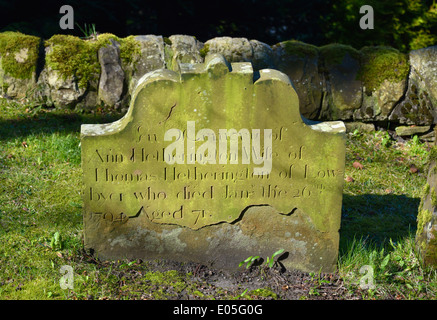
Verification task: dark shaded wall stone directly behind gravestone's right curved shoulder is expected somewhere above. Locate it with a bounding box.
[273,41,325,120]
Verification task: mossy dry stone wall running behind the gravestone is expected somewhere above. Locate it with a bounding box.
[0,32,437,138]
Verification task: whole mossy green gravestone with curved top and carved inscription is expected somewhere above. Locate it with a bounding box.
[81,54,345,271]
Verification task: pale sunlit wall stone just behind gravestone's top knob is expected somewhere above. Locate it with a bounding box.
[203,37,253,63]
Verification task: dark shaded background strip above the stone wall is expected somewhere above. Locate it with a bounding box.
[0,0,437,51]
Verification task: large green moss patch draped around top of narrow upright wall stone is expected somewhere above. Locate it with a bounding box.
[45,33,140,88]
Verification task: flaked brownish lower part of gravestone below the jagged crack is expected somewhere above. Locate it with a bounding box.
[85,206,339,272]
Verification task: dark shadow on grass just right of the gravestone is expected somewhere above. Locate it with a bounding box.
[340,194,420,252]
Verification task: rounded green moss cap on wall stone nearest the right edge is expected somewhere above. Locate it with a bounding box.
[357,46,410,94]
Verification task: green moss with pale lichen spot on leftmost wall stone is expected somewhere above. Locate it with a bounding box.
[0,31,41,79]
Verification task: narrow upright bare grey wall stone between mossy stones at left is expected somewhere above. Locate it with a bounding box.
[98,39,125,107]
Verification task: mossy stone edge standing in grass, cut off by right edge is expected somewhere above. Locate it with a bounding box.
[416,147,437,267]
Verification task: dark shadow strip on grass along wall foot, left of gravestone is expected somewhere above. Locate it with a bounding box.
[0,111,123,140]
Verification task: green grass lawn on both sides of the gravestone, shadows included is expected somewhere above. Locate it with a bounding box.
[0,100,437,299]
